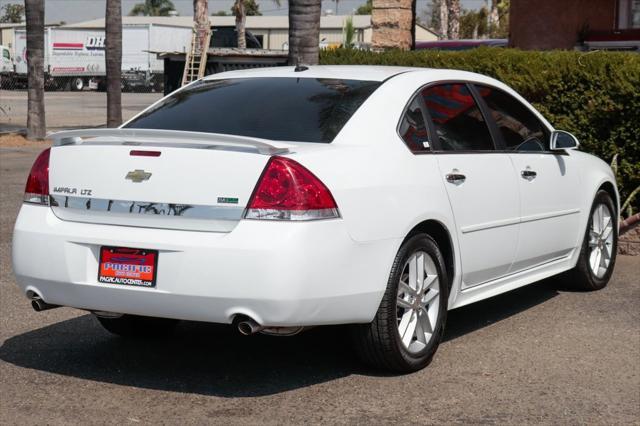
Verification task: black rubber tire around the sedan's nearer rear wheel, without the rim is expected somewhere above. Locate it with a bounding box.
[351,234,449,373]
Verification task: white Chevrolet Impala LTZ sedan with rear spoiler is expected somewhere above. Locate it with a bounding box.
[13,66,618,372]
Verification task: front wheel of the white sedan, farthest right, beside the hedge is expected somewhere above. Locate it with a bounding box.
[567,190,618,290]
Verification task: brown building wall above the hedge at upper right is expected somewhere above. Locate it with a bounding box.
[509,0,617,49]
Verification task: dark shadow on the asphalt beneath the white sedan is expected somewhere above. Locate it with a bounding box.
[0,282,558,398]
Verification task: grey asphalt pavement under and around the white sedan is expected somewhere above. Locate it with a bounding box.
[0,142,640,424]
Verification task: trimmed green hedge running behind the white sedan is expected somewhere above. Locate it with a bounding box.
[320,48,640,211]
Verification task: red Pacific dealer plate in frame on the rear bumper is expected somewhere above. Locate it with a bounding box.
[98,246,159,288]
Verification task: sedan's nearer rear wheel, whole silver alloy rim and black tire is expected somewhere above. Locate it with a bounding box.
[352,234,449,373]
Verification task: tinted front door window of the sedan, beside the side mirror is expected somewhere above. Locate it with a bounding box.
[476,85,549,152]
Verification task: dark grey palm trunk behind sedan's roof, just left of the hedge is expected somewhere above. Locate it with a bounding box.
[289,0,321,65]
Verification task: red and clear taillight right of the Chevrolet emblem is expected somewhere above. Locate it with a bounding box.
[244,156,340,220]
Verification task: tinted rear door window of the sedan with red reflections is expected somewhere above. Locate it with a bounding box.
[422,83,494,151]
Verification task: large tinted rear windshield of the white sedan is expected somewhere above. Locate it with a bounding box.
[125,77,380,143]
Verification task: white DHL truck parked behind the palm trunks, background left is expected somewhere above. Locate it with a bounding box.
[10,24,192,91]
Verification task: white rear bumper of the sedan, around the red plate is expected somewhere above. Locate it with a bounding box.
[13,204,399,326]
